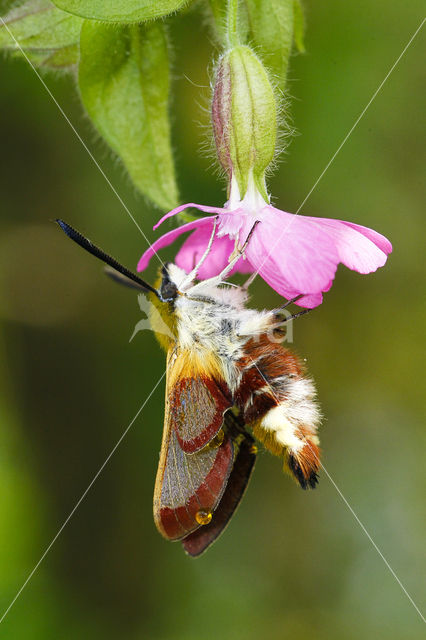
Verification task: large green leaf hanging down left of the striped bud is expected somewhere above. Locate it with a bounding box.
[79,21,178,209]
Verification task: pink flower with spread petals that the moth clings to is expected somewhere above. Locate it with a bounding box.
[138,181,392,308]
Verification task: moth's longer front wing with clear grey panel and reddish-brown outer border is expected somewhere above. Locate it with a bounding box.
[154,352,234,540]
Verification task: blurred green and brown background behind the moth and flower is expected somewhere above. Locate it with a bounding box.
[0,0,426,640]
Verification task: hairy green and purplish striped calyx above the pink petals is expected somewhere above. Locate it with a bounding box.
[212,45,277,201]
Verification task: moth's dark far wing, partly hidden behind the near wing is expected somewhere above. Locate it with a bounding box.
[182,438,256,556]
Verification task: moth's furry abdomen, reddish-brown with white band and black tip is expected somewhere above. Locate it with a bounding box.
[235,336,320,489]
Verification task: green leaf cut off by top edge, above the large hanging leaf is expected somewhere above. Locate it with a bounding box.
[50,0,189,24]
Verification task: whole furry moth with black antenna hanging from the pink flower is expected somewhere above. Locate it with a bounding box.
[57,220,320,556]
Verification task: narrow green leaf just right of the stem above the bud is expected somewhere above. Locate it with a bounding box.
[245,0,294,88]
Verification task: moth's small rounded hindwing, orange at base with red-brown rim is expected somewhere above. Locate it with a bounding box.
[168,350,232,453]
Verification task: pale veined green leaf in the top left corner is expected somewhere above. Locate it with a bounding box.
[0,0,83,68]
